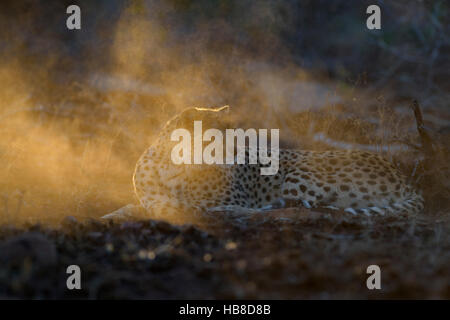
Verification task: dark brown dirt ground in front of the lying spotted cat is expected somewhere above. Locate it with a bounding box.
[0,209,450,299]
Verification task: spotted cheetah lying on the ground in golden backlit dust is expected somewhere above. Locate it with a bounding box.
[102,106,423,219]
